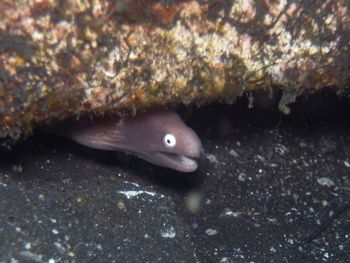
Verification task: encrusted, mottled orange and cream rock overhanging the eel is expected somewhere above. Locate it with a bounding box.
[0,0,350,139]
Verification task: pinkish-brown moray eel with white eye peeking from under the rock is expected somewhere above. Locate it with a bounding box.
[55,109,202,173]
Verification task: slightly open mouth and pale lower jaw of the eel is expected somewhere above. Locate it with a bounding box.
[147,152,198,173]
